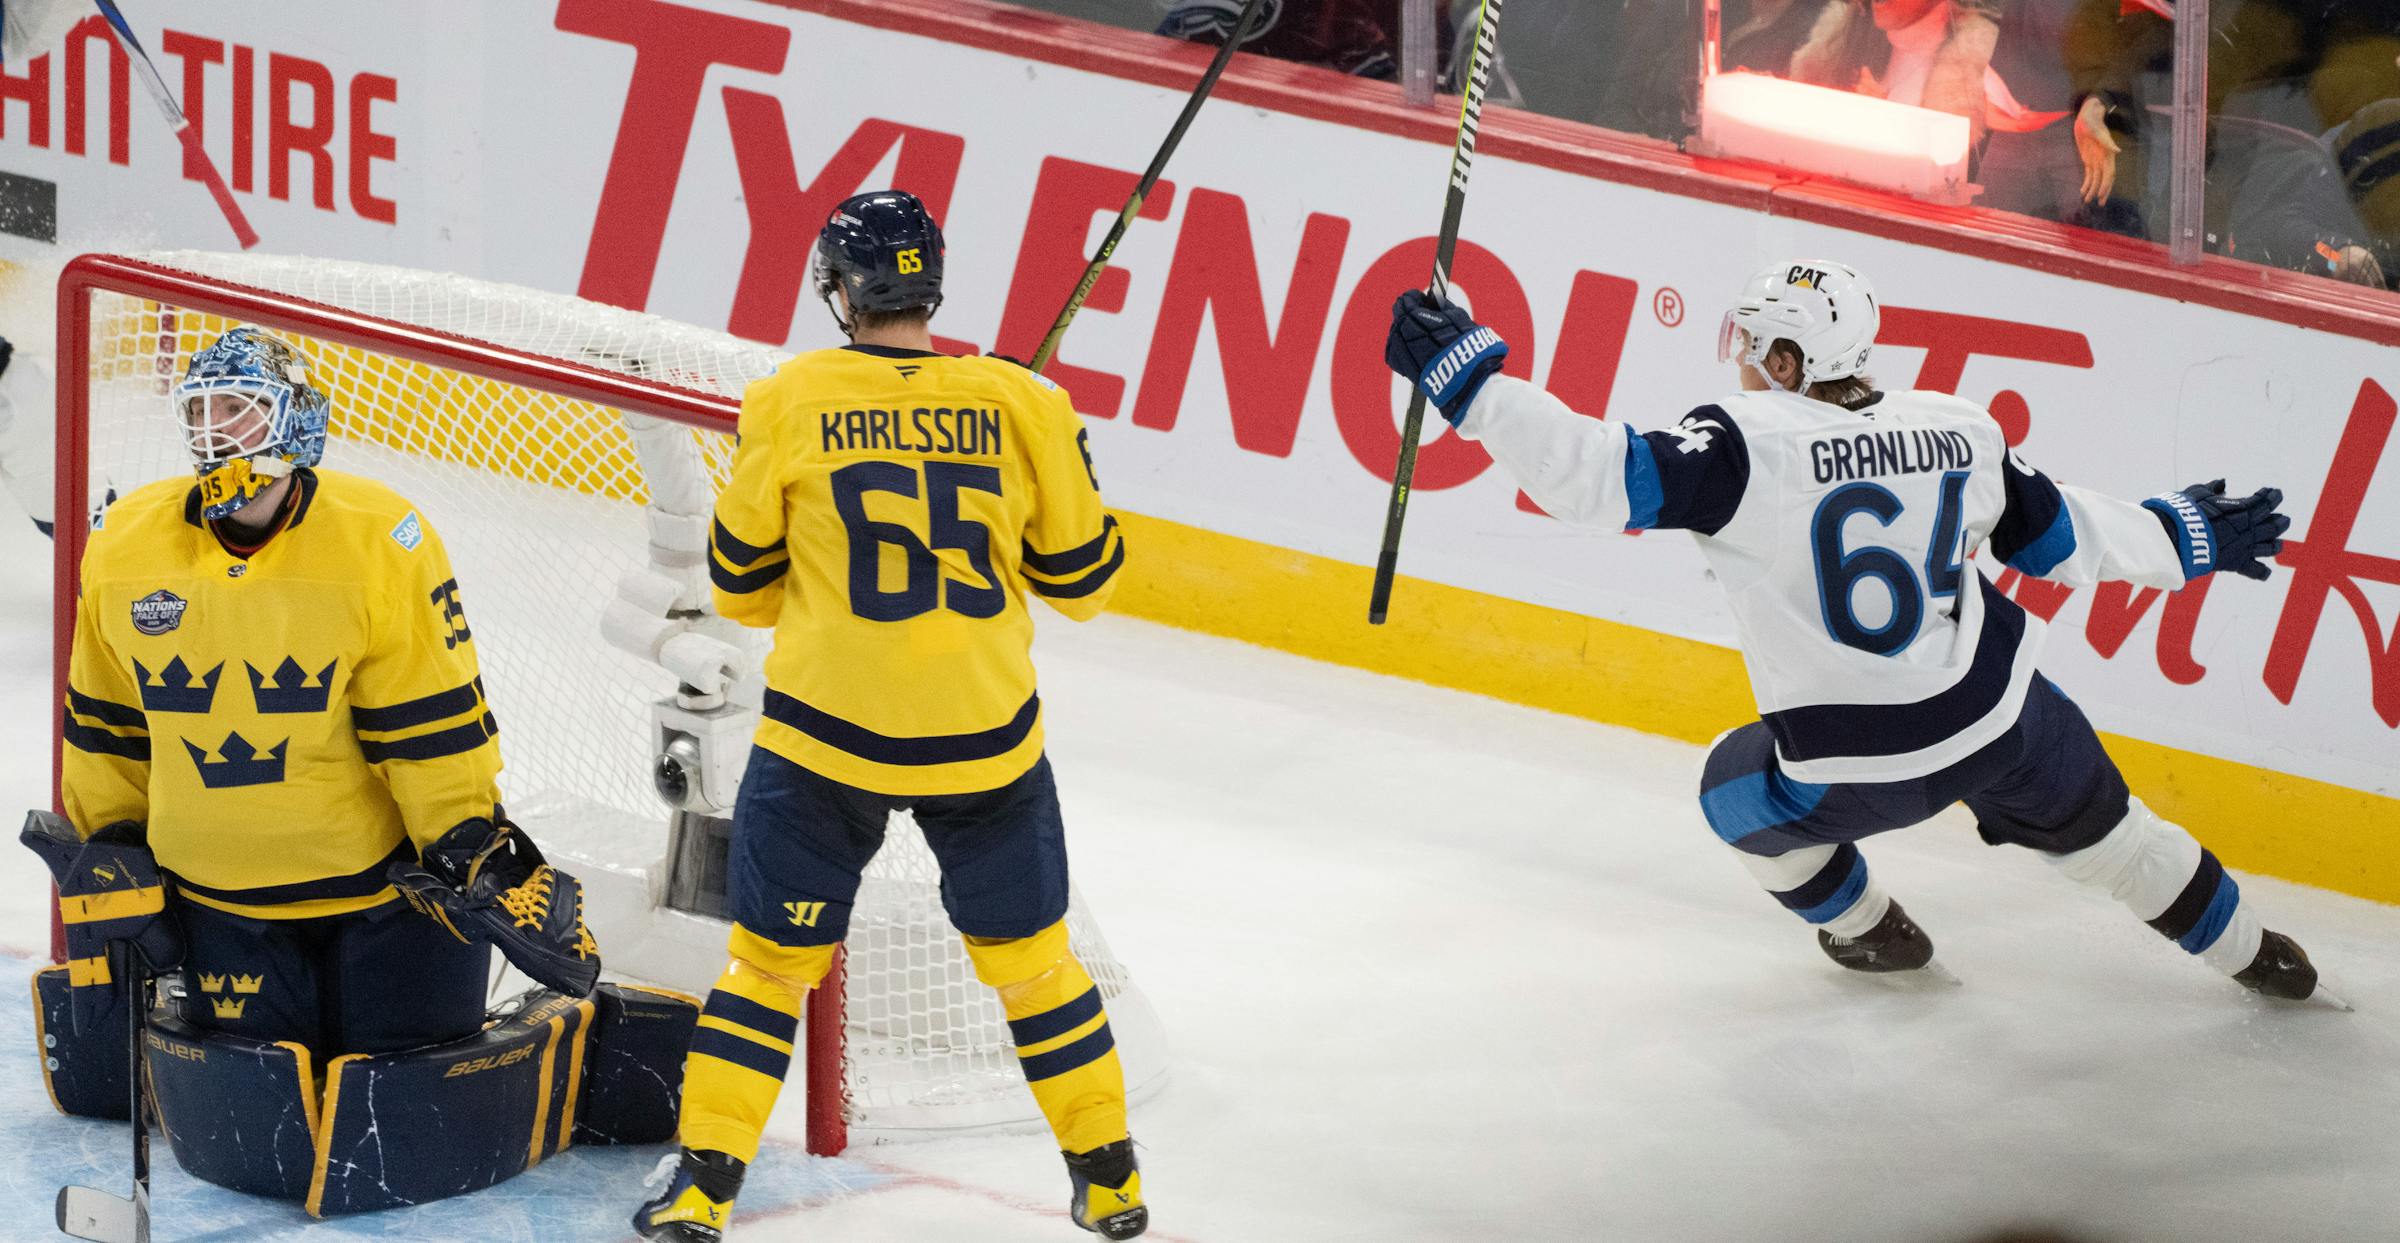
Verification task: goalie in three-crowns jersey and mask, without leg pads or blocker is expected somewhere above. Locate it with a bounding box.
[60,329,598,1058]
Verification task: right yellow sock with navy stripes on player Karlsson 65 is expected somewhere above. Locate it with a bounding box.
[967,921,1126,1152]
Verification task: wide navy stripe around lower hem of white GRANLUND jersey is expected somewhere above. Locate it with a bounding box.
[1759,574,2026,763]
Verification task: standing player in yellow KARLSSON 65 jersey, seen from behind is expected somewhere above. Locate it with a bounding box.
[634,192,1150,1243]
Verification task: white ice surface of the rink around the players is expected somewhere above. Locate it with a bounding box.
[0,506,2400,1243]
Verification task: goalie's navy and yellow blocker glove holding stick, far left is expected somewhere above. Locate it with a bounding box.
[17,811,182,1034]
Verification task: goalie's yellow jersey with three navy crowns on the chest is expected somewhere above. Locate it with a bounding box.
[60,470,499,919]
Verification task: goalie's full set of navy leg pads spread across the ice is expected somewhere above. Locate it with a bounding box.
[34,965,698,1217]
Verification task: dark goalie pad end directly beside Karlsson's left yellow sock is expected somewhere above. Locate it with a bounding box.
[574,984,701,1145]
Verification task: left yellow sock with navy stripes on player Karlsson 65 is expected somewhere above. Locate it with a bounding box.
[682,924,835,1164]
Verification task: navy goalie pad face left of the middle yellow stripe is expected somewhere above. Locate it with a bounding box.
[142,1017,317,1200]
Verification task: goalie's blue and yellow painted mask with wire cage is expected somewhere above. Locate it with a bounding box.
[168,329,334,518]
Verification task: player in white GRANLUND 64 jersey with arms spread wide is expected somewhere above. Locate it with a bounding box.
[1385,259,2333,1001]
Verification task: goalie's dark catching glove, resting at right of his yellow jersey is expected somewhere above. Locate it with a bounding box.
[389,818,600,996]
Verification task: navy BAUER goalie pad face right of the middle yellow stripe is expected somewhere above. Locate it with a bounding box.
[307,989,598,1217]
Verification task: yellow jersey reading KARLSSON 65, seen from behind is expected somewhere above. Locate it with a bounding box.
[710,346,1126,794]
